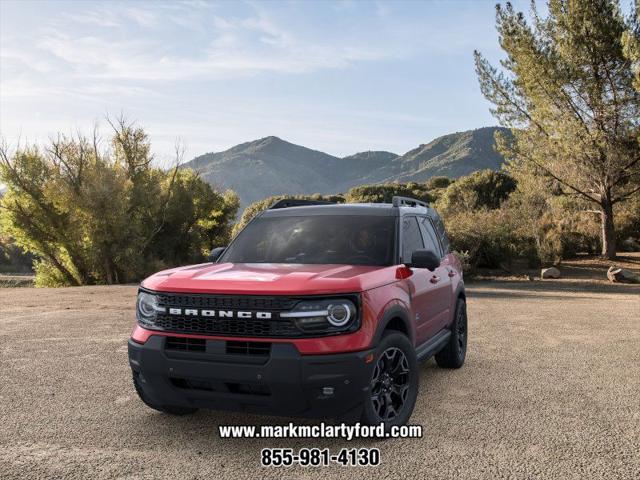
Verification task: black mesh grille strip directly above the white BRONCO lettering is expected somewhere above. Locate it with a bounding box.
[158,293,299,311]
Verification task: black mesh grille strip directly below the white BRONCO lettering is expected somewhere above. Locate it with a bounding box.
[154,315,302,337]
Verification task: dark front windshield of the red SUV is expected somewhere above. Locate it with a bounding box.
[220,215,396,266]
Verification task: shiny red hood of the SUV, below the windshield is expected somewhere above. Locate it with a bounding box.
[142,263,396,295]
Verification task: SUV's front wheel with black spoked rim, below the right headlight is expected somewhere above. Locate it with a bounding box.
[360,331,418,429]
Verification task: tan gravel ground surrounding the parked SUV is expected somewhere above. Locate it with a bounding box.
[0,281,640,479]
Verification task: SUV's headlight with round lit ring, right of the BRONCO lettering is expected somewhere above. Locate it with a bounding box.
[280,299,358,333]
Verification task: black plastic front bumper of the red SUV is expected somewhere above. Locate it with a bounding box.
[129,335,373,418]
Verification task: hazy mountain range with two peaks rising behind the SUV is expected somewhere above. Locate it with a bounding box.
[183,127,509,206]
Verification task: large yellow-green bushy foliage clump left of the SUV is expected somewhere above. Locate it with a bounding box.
[0,120,238,286]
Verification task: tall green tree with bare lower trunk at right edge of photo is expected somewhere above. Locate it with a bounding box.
[475,0,640,258]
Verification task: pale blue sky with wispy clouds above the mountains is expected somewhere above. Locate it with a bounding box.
[0,0,528,162]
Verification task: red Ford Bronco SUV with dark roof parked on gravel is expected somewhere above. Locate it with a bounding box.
[129,197,467,426]
